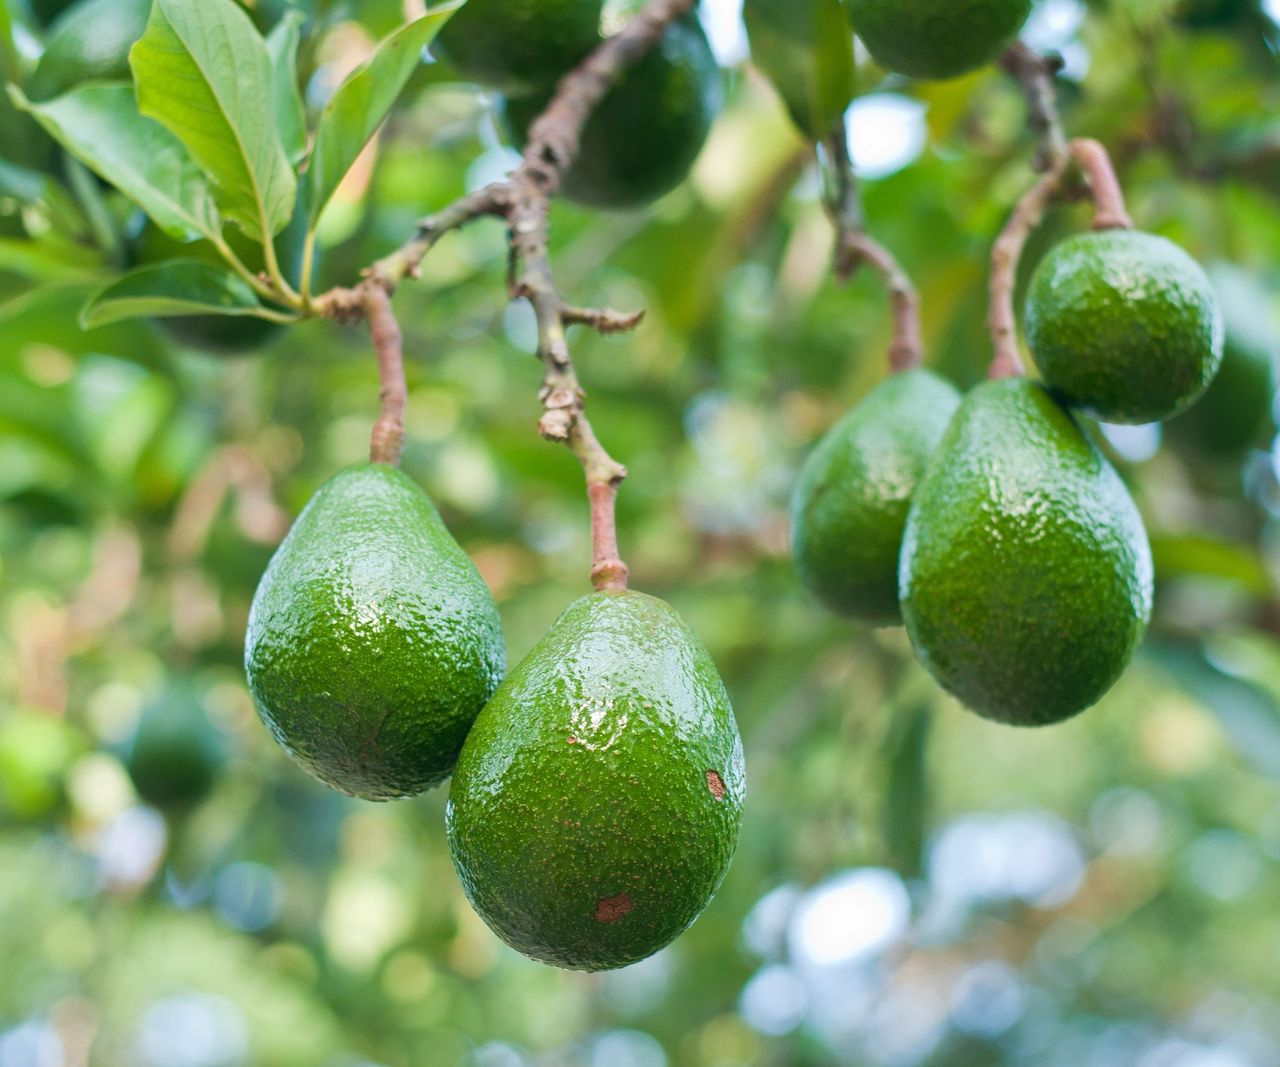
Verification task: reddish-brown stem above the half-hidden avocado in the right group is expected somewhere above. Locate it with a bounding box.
[820,122,924,372]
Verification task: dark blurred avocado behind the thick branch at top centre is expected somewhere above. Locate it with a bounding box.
[502,18,723,209]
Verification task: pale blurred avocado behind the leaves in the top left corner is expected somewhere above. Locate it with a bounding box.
[27,0,151,100]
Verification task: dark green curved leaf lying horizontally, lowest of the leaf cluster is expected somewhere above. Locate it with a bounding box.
[79,260,264,330]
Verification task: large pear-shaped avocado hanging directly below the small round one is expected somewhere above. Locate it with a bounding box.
[900,379,1152,725]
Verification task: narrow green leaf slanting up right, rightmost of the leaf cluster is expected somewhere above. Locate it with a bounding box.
[310,4,461,229]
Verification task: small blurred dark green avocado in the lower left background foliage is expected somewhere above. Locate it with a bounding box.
[124,686,227,810]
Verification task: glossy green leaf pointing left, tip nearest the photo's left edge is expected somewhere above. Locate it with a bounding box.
[12,83,221,241]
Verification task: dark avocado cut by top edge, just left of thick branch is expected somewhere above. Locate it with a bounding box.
[431,0,603,93]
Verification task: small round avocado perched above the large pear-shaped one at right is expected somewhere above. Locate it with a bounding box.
[1027,230,1222,423]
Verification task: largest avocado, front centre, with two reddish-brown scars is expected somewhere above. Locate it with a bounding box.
[447,592,745,971]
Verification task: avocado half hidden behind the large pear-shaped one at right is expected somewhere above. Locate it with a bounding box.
[791,370,960,626]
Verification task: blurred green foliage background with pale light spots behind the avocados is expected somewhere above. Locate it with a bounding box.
[0,0,1280,1067]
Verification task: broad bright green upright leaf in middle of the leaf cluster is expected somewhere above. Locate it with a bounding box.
[129,0,297,241]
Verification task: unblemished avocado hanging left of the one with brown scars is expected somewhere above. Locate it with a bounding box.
[244,463,506,800]
